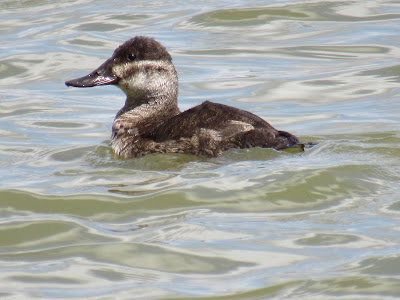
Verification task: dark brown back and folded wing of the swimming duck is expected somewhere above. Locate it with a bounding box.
[148,101,299,156]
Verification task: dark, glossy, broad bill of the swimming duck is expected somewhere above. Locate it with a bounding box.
[65,60,118,87]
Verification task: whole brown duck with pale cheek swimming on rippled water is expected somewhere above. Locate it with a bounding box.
[65,36,304,159]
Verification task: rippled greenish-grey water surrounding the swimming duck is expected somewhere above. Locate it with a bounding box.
[0,0,400,299]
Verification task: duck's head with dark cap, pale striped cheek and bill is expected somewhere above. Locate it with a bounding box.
[65,36,178,105]
